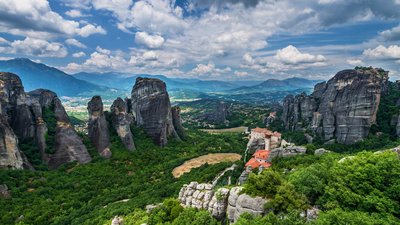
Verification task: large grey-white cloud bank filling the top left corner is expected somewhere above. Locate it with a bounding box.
[0,0,105,38]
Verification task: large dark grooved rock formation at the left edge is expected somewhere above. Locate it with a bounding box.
[0,73,91,168]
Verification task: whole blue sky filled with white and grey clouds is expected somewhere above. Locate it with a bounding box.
[0,0,400,80]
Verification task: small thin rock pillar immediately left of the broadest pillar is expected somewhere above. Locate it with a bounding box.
[111,98,135,150]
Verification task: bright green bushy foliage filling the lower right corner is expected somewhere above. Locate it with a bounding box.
[238,151,400,225]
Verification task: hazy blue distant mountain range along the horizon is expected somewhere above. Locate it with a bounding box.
[0,58,318,99]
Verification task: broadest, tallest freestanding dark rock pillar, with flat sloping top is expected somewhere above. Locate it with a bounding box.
[131,77,180,146]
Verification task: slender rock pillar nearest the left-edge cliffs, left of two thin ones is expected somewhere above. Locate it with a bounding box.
[87,96,111,158]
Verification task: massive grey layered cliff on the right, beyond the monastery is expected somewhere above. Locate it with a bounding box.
[282,68,388,144]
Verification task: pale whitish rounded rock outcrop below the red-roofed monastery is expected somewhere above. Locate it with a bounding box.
[178,182,266,223]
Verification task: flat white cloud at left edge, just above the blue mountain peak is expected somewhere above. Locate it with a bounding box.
[0,37,68,58]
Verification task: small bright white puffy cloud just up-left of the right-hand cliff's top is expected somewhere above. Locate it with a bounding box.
[275,45,326,64]
